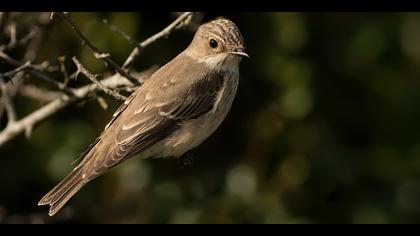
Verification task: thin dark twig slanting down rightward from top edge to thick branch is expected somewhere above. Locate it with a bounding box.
[58,12,139,85]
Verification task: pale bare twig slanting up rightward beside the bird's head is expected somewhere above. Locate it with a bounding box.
[122,12,193,69]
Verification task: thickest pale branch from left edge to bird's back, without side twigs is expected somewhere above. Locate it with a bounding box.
[0,67,156,147]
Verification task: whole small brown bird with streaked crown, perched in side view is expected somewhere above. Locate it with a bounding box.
[38,18,249,216]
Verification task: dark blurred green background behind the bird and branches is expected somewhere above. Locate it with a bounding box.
[0,12,420,223]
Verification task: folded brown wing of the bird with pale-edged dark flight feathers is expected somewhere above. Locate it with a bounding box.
[85,68,224,181]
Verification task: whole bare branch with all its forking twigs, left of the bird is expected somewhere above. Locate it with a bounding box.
[0,12,193,147]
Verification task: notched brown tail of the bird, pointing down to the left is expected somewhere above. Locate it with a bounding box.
[38,168,86,216]
